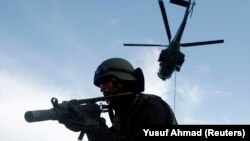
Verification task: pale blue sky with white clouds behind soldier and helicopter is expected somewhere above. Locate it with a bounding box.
[0,0,250,141]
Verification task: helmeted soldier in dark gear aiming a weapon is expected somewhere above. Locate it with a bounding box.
[60,58,177,141]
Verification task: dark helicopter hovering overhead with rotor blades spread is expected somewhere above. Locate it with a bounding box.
[123,0,224,81]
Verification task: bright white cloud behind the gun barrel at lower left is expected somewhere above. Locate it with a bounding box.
[0,70,85,141]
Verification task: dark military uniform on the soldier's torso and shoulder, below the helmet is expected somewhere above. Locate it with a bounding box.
[87,93,177,141]
